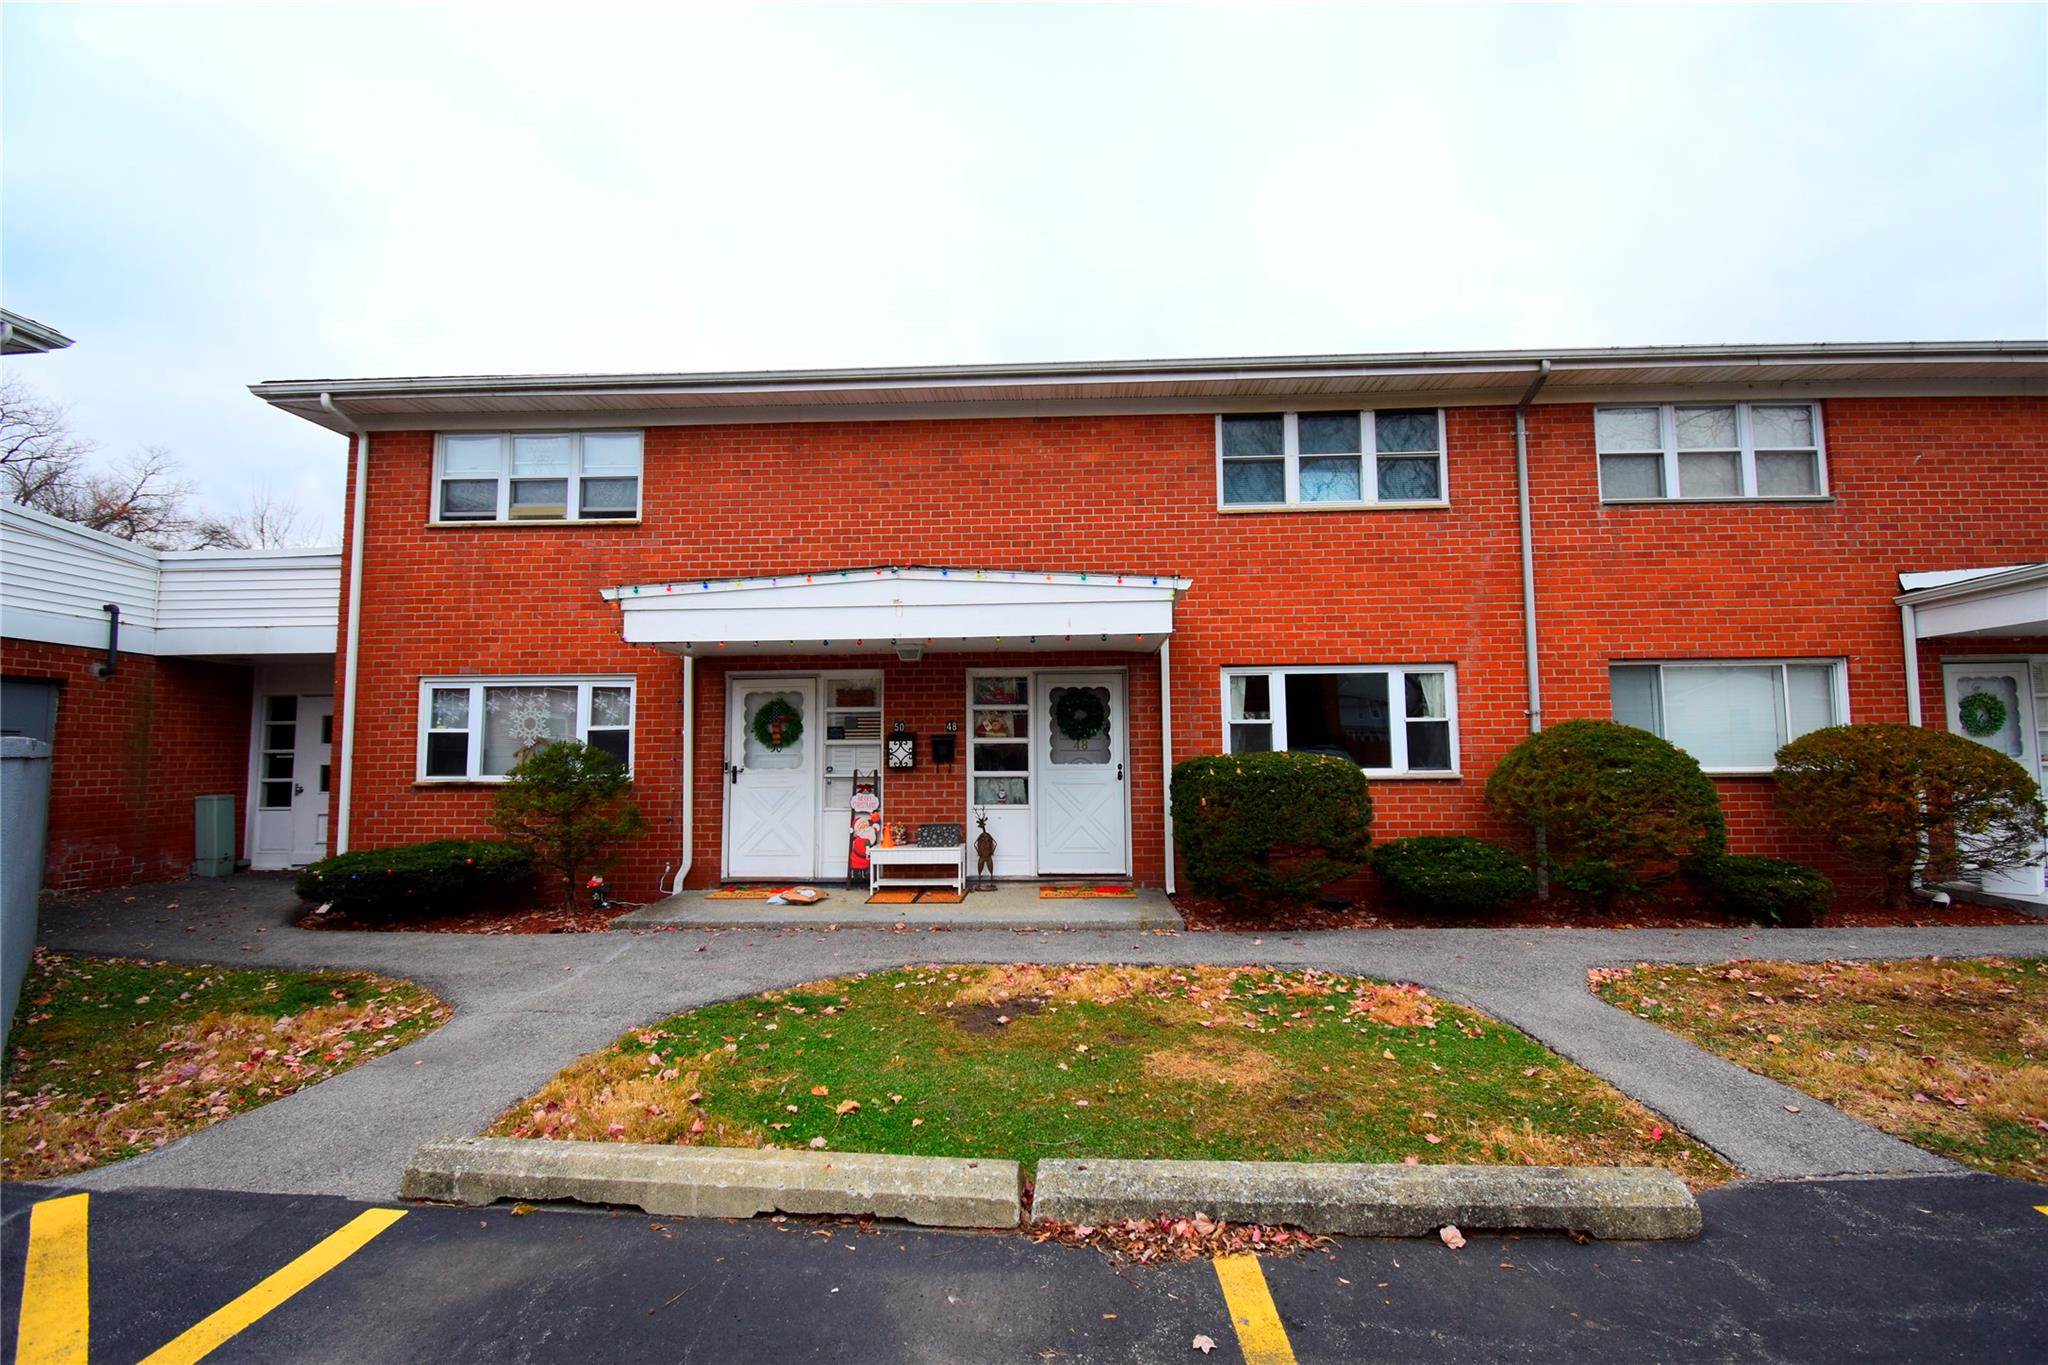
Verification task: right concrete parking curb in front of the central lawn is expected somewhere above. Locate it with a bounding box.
[1032,1160,1700,1240]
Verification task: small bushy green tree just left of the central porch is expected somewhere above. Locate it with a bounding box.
[492,739,647,909]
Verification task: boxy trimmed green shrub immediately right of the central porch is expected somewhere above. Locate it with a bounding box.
[1174,753,1372,900]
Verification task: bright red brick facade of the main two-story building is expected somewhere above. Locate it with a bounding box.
[327,397,2048,898]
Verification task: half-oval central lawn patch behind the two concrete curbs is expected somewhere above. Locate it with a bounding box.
[492,966,1733,1185]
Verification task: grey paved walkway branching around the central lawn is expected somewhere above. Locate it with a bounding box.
[24,876,2048,1199]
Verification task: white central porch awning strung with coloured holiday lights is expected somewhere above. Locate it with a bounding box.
[604,565,1190,653]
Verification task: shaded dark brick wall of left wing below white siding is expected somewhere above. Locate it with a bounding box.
[0,641,250,890]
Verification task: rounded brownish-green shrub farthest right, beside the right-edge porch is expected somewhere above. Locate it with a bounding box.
[1774,724,2048,907]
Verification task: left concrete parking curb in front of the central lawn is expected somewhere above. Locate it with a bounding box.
[397,1138,1024,1228]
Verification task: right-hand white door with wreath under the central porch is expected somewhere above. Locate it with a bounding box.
[1032,673,1130,876]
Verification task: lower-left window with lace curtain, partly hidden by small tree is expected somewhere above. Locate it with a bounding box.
[418,677,633,782]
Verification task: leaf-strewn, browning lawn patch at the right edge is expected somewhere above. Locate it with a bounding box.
[1593,958,2048,1181]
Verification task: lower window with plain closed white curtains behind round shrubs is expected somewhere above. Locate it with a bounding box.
[1608,659,1847,772]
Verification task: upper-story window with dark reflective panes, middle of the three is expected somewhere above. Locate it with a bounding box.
[1217,407,1444,508]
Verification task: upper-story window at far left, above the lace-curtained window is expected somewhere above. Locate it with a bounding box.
[434,432,641,522]
